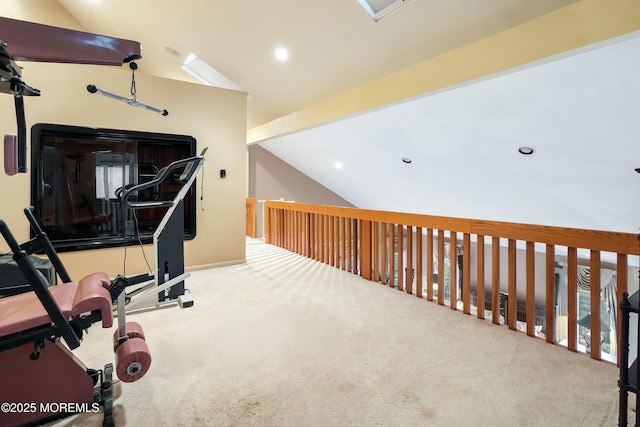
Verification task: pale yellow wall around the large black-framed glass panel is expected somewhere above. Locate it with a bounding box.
[0,5,246,278]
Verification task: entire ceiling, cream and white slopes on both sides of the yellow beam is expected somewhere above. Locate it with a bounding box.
[52,0,640,233]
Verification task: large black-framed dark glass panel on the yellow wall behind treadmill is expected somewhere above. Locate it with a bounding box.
[31,123,196,252]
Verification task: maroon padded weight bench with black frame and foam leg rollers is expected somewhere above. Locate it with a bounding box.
[0,208,151,426]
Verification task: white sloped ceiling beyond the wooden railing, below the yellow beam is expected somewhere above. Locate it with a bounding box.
[260,34,640,233]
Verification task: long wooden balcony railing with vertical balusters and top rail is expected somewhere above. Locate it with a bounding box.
[265,201,640,361]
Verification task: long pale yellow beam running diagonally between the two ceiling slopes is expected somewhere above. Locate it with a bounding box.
[247,0,640,144]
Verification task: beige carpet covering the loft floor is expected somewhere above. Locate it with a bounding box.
[51,240,618,426]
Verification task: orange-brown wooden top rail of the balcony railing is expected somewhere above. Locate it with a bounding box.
[265,200,640,255]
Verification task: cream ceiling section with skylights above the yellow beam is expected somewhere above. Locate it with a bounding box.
[57,0,576,128]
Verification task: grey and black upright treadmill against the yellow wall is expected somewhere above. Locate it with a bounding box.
[109,148,207,311]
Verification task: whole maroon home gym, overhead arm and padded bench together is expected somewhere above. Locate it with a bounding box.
[0,17,151,426]
